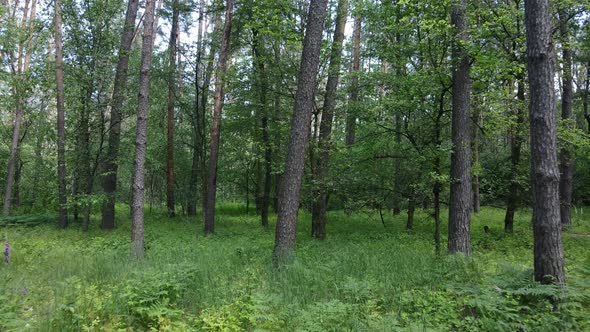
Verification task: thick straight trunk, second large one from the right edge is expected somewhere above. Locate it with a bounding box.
[448,0,472,255]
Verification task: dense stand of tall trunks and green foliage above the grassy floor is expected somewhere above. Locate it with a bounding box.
[0,0,590,330]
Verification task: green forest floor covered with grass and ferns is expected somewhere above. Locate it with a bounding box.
[0,204,590,331]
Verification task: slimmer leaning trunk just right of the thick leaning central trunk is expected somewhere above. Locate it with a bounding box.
[311,0,348,240]
